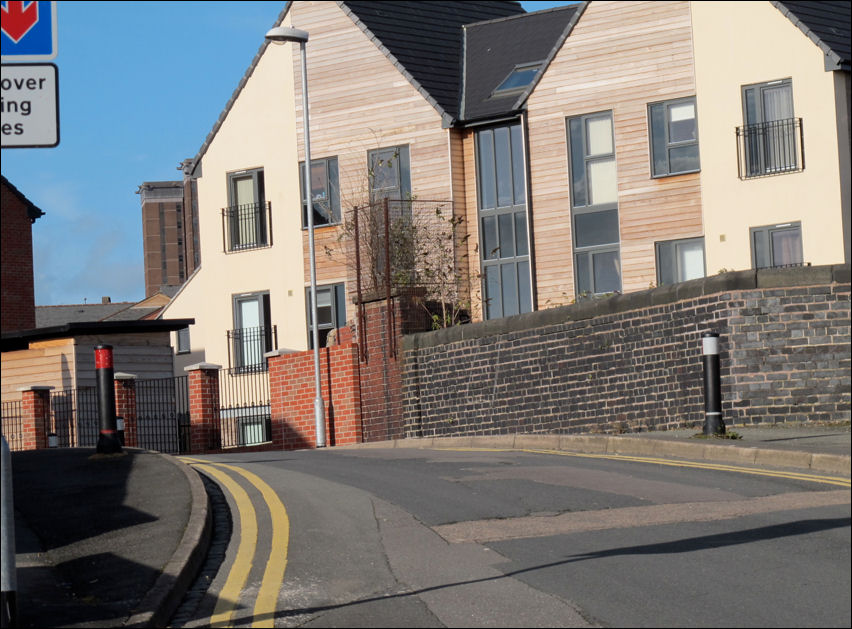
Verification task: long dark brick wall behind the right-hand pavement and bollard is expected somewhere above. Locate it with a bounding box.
[402,265,850,436]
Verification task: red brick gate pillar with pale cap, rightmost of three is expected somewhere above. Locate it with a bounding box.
[184,363,222,454]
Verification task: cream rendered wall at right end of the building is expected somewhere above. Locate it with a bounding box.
[690,2,843,275]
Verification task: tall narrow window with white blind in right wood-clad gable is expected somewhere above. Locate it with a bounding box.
[568,111,621,295]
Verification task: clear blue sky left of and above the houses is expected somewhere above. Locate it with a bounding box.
[0,0,571,306]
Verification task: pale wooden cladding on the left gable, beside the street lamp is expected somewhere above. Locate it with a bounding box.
[290,2,453,293]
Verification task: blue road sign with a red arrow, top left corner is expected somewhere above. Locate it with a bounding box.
[0,0,57,63]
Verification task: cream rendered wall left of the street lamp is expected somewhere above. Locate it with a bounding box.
[163,20,307,375]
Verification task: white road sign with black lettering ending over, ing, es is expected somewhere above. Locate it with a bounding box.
[0,63,59,149]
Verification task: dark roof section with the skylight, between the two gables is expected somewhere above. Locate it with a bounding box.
[460,4,585,121]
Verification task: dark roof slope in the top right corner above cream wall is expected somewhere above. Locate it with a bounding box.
[772,1,852,72]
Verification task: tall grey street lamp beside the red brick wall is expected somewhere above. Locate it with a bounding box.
[266,26,325,448]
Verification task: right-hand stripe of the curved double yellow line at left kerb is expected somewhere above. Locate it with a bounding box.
[180,457,290,627]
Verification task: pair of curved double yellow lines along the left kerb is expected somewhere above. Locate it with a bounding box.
[180,457,290,627]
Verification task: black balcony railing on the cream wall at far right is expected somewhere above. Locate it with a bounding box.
[737,118,805,179]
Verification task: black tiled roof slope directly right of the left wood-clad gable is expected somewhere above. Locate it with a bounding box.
[338,0,524,124]
